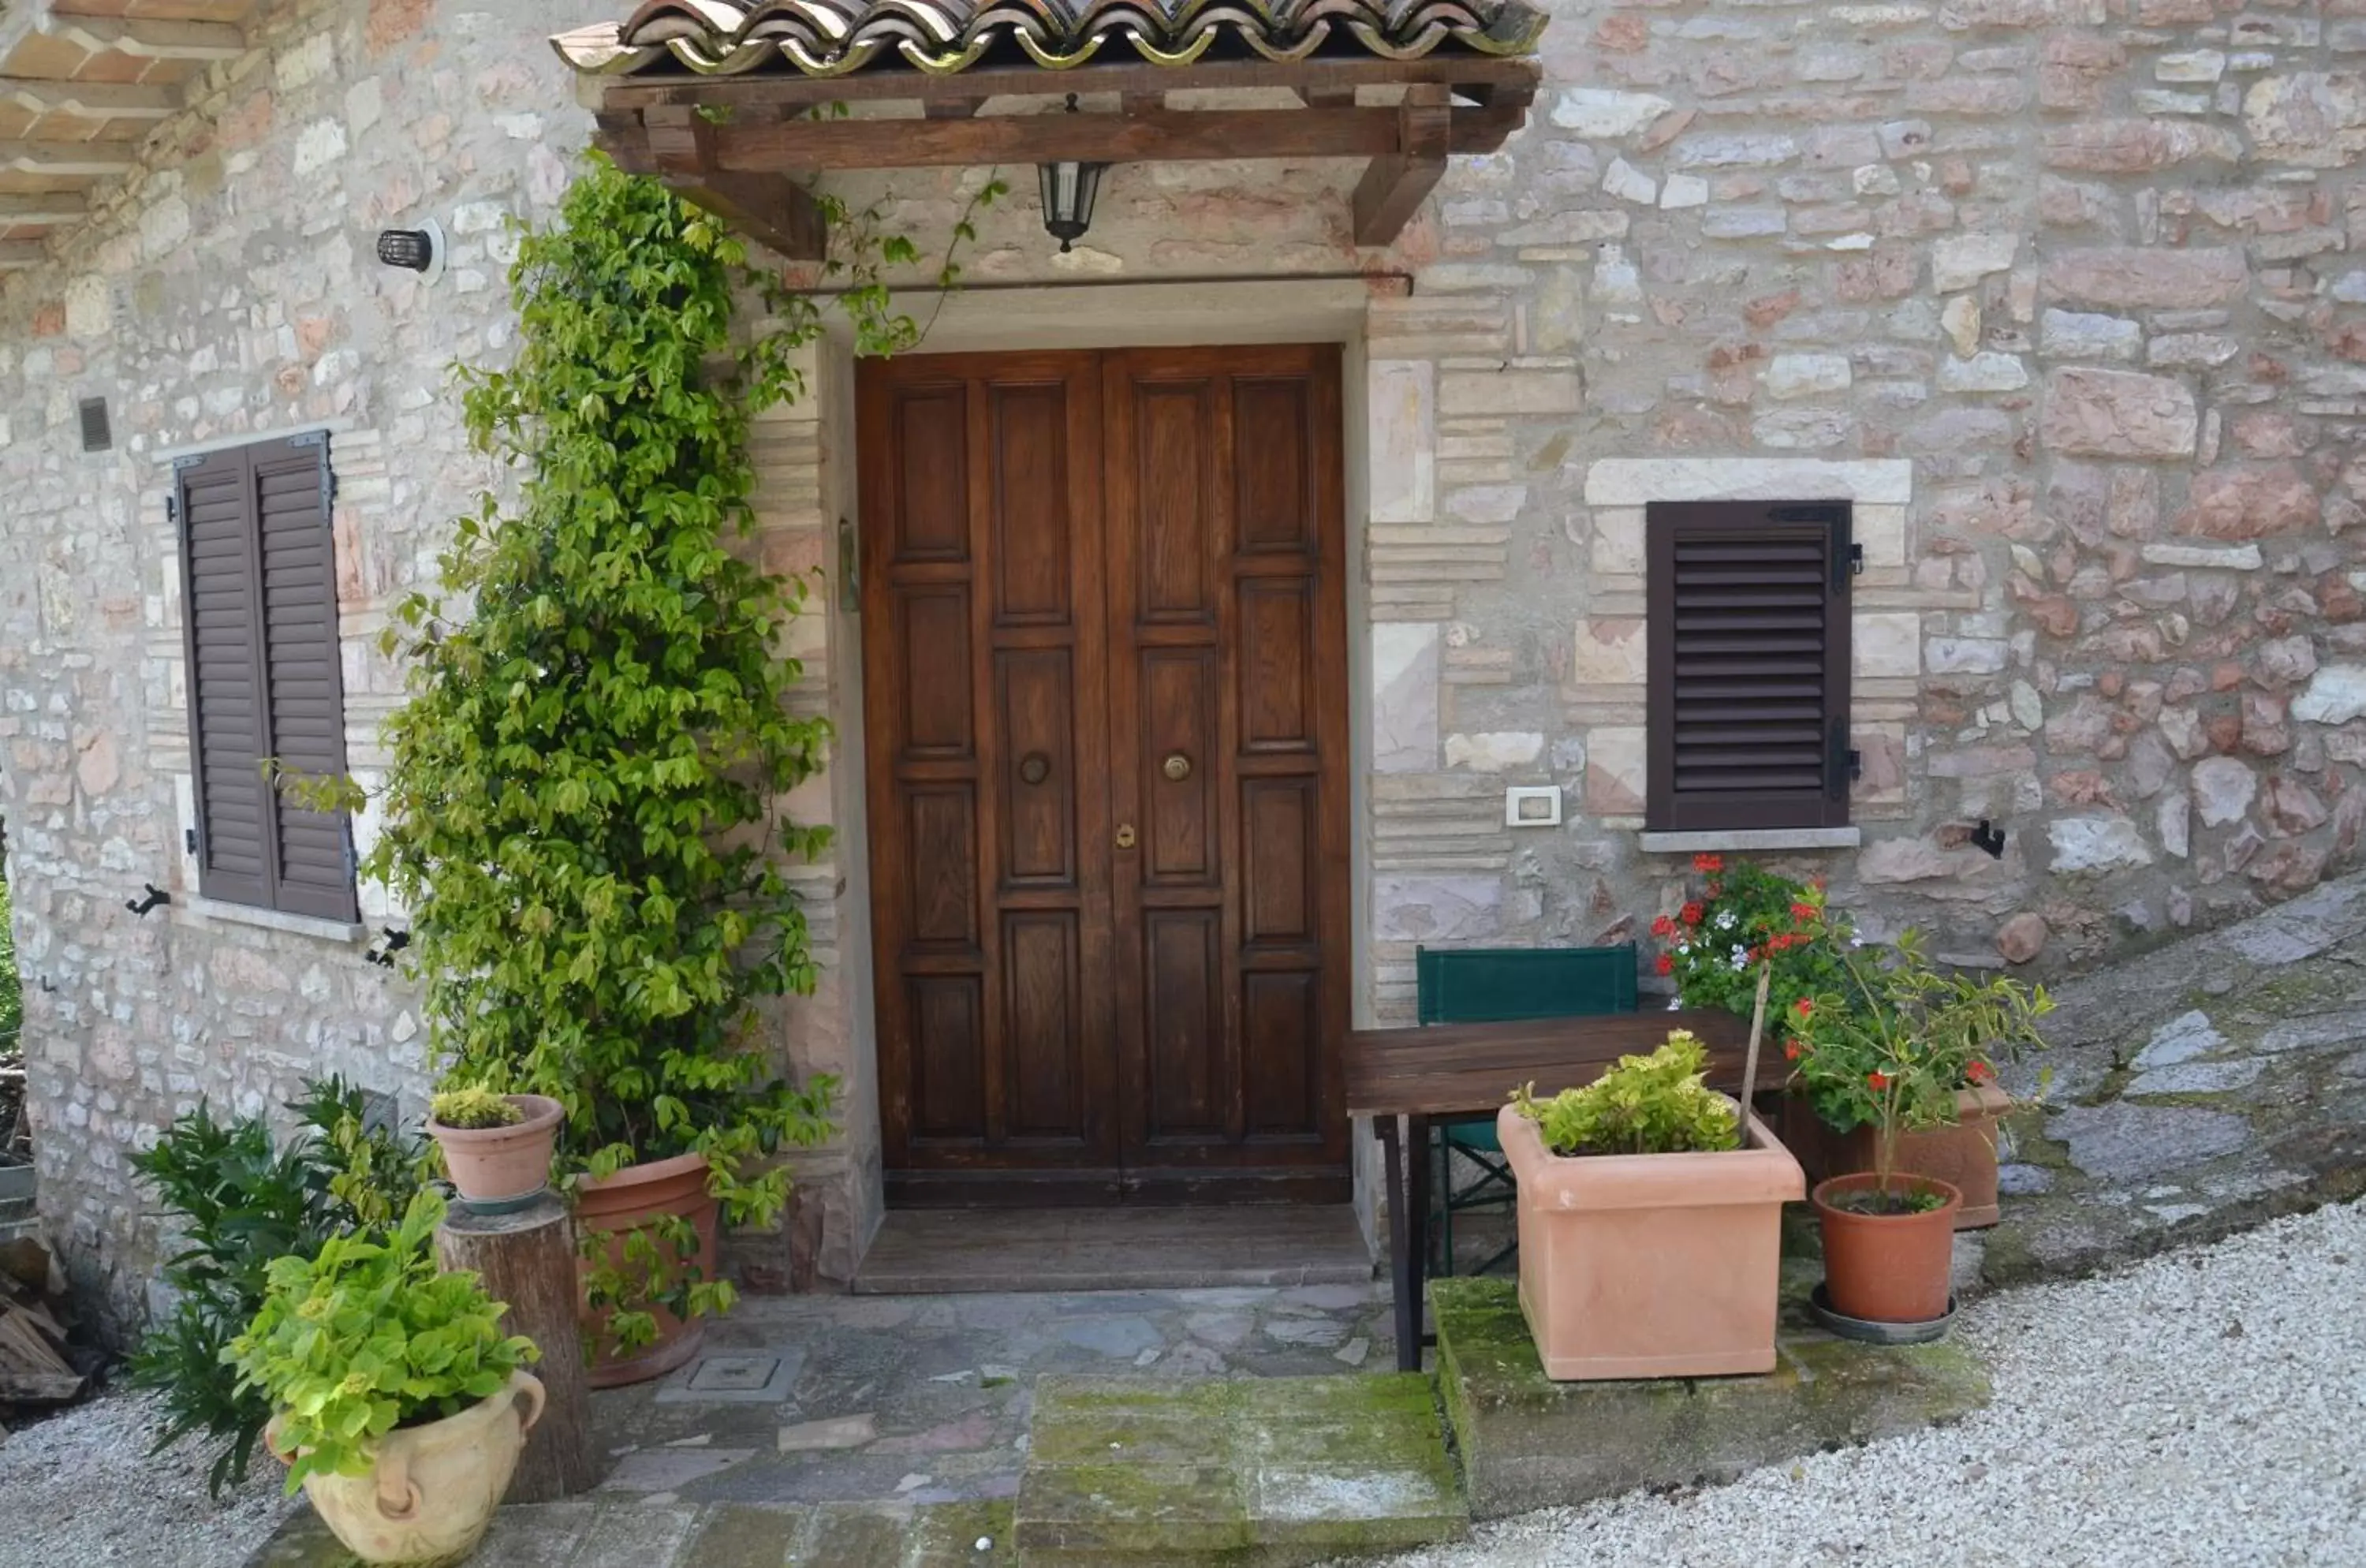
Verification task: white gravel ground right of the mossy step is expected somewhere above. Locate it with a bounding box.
[1398,1204,2366,1568]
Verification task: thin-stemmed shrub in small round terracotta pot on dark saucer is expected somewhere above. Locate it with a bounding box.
[1784,931,2054,1336]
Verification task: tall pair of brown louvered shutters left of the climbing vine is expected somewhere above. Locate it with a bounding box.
[182,435,357,920]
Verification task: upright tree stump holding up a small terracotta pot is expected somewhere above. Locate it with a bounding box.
[435,1192,599,1502]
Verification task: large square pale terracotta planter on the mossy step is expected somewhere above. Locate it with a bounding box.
[1495,1107,1808,1381]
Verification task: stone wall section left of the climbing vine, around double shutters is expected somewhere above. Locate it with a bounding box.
[0,0,629,1315]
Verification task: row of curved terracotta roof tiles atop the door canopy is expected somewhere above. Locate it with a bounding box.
[551,0,1545,76]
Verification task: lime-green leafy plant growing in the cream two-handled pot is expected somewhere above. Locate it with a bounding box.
[225,1189,539,1492]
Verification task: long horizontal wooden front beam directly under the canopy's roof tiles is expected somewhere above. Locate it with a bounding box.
[601,54,1545,118]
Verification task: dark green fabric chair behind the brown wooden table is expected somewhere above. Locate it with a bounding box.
[1413,941,1640,1275]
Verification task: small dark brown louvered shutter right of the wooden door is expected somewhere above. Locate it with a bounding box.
[1644,502,1850,832]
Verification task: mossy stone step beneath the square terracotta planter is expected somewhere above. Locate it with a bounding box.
[1429,1275,1987,1518]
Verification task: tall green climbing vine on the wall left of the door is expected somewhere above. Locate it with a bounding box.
[367,156,1001,1346]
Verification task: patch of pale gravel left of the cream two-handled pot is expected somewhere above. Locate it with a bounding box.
[0,1393,291,1568]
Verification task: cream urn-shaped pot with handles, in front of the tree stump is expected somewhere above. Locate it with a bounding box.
[265,1372,542,1568]
